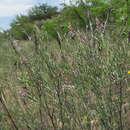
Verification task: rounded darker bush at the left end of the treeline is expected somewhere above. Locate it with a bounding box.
[9,4,58,39]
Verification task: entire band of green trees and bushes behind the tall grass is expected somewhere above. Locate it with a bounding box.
[10,0,129,39]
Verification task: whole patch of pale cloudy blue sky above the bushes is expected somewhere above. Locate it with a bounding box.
[0,0,68,30]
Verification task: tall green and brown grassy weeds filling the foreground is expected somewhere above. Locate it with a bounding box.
[0,28,130,130]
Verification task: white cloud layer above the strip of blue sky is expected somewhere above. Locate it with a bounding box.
[0,0,67,17]
